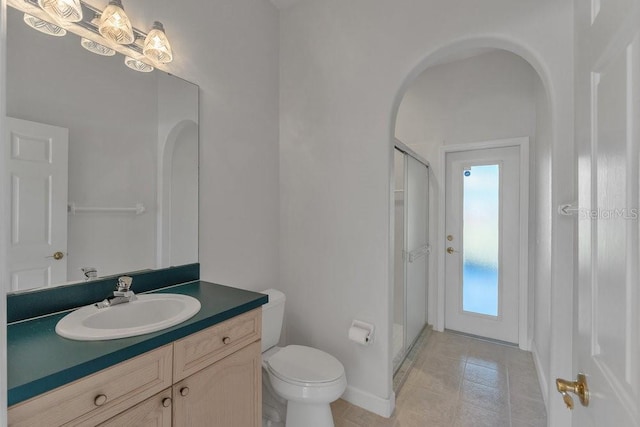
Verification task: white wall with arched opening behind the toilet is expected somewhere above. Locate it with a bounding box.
[280,0,573,414]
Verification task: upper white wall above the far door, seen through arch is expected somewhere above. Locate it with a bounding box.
[396,50,537,149]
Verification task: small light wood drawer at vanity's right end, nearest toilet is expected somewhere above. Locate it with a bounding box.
[173,308,262,381]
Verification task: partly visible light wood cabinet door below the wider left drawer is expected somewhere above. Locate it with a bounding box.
[94,388,172,427]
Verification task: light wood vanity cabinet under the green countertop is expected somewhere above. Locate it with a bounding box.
[8,308,262,427]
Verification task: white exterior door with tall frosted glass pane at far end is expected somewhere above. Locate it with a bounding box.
[444,146,520,343]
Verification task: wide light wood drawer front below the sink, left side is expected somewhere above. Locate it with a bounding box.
[8,345,173,426]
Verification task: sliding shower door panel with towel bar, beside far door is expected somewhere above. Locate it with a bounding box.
[404,154,429,346]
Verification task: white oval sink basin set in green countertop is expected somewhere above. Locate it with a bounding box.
[56,294,200,341]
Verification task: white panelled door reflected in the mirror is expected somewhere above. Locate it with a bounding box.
[5,117,69,291]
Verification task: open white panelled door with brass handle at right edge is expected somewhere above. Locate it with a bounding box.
[568,0,640,427]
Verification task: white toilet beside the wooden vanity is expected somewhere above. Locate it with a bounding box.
[262,289,347,427]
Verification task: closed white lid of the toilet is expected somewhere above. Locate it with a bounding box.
[267,345,344,383]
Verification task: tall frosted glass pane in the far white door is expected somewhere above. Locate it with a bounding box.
[462,165,500,316]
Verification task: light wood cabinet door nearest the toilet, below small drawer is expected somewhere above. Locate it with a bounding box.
[173,341,262,427]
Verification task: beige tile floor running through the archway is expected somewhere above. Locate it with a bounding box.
[331,332,547,427]
